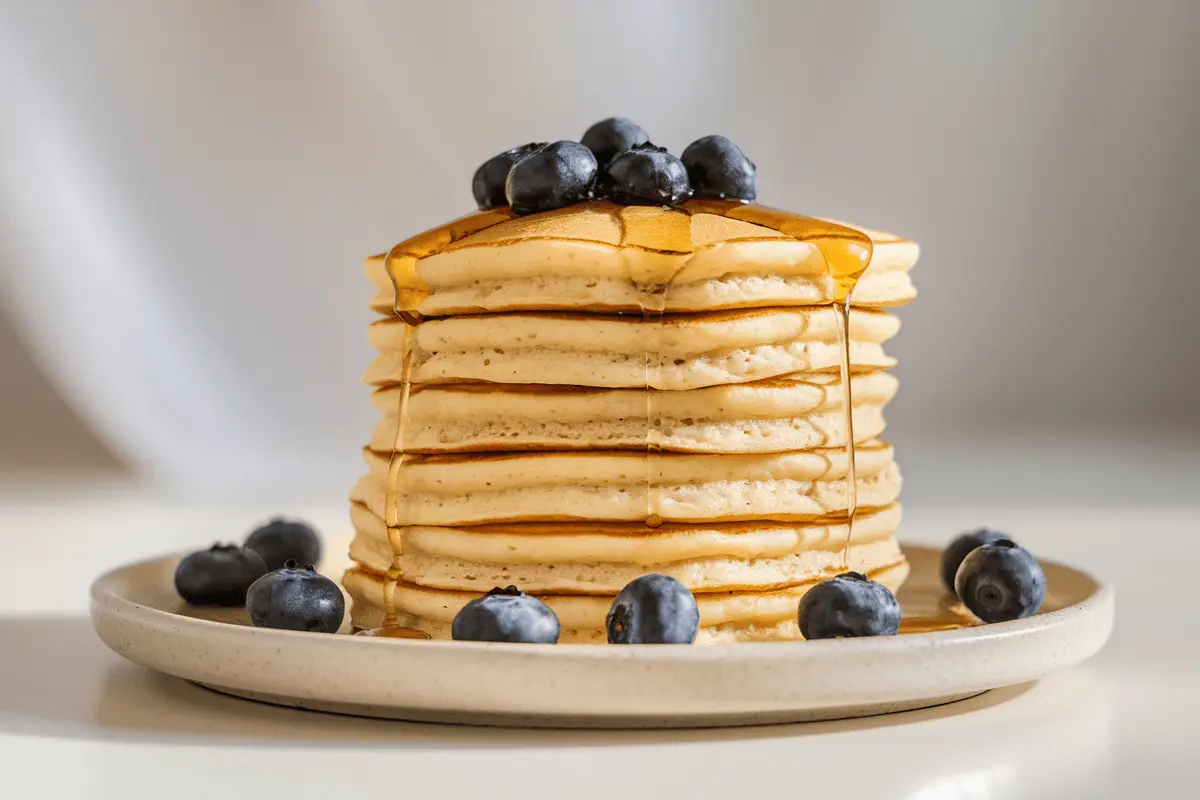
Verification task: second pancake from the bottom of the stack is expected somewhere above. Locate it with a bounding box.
[350,504,901,595]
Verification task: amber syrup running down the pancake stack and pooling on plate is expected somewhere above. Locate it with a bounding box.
[368,200,968,638]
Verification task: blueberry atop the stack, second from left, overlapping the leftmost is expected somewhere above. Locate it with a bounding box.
[504,142,596,213]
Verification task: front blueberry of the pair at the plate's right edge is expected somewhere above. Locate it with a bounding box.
[954,539,1046,622]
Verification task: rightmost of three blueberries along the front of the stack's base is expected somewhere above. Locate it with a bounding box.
[799,572,900,639]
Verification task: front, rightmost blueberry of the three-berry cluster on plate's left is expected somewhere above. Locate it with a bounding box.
[246,561,346,633]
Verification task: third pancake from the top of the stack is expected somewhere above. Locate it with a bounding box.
[370,372,898,453]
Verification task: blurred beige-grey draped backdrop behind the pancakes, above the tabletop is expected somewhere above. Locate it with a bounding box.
[0,0,1200,504]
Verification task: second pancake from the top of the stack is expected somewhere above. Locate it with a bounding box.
[364,307,900,391]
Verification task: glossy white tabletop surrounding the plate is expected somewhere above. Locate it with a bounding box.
[0,474,1200,800]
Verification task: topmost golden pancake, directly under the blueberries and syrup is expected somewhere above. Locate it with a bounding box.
[366,200,919,317]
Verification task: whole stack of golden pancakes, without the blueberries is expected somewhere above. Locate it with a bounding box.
[344,201,917,642]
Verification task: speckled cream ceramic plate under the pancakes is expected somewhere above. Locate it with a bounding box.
[91,546,1114,728]
